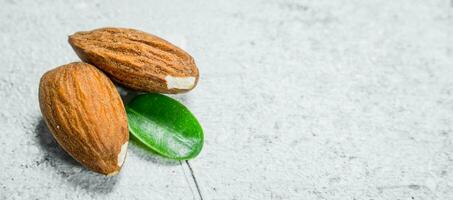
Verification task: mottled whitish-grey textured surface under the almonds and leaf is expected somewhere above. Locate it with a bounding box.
[0,0,453,200]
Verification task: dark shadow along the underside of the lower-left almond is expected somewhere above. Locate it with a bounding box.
[34,117,120,194]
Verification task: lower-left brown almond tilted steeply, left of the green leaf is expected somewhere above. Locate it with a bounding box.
[39,62,129,175]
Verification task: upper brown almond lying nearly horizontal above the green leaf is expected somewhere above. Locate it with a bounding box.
[68,28,199,93]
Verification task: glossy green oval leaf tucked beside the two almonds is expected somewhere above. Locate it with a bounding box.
[126,94,203,160]
